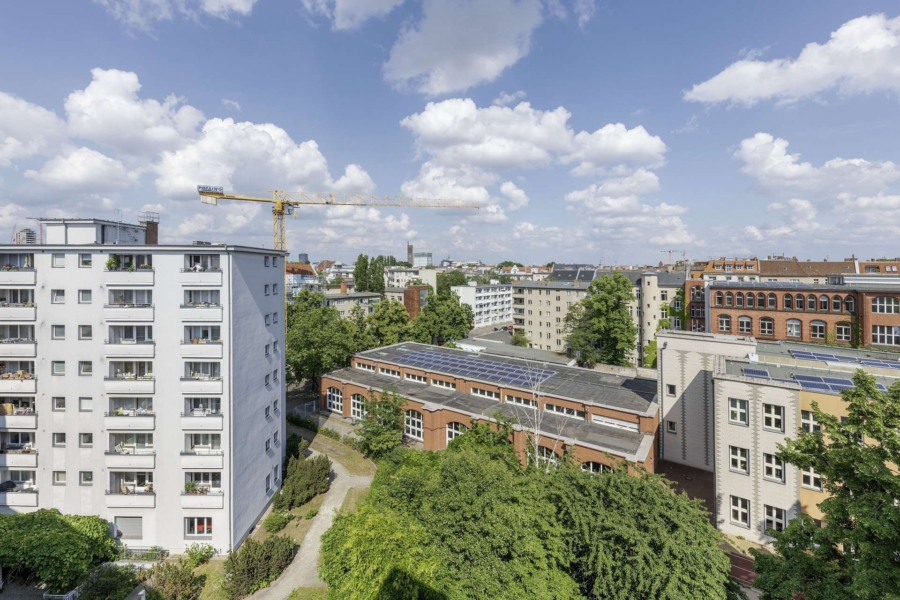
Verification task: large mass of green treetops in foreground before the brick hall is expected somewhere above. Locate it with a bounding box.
[320,432,730,600]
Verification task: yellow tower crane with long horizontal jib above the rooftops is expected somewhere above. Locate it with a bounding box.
[197,185,478,251]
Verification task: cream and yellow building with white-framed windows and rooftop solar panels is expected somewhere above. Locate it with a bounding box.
[658,332,900,543]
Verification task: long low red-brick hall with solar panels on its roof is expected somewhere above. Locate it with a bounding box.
[319,342,658,472]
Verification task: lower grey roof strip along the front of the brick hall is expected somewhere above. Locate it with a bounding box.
[325,367,655,462]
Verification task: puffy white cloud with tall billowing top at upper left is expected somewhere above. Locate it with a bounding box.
[65,69,205,156]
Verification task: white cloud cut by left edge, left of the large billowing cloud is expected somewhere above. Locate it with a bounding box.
[0,92,66,167]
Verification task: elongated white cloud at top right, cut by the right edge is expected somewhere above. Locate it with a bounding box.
[684,15,900,106]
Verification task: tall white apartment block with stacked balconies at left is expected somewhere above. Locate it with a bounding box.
[0,219,285,552]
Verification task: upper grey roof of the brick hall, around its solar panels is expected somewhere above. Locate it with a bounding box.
[356,342,658,416]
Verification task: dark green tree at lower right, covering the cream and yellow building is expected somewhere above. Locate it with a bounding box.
[755,370,900,600]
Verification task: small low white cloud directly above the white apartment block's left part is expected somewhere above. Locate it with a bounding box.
[25,148,139,192]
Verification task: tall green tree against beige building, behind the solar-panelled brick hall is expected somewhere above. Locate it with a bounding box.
[566,273,637,368]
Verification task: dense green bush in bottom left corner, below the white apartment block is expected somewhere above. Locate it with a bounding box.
[0,509,117,593]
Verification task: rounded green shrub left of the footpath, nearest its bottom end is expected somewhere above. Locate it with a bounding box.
[224,535,294,600]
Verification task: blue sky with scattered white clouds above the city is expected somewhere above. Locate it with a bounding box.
[0,0,900,264]
